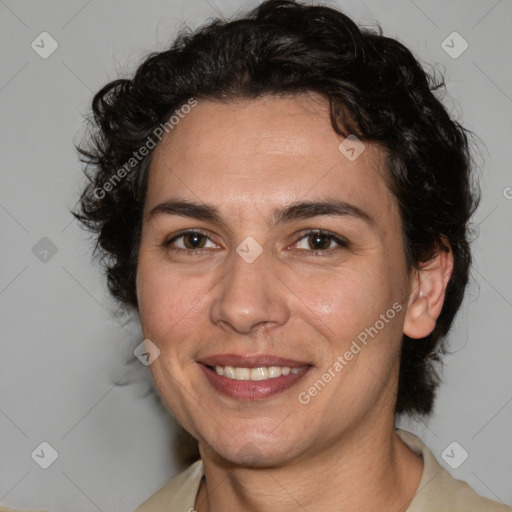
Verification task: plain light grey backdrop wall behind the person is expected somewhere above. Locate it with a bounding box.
[0,0,512,512]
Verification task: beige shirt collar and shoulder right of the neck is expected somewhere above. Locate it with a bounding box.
[397,430,512,512]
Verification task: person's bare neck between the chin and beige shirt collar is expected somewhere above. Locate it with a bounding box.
[196,418,423,512]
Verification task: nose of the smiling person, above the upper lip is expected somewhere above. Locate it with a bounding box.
[210,249,289,334]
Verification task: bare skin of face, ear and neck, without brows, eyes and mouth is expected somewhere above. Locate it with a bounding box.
[137,94,452,512]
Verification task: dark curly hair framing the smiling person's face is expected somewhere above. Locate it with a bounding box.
[73,0,478,414]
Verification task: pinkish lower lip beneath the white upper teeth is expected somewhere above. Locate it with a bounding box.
[199,363,311,400]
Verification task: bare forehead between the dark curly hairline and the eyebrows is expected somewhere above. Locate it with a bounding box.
[146,94,396,226]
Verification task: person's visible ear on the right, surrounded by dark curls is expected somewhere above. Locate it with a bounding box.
[403,239,453,339]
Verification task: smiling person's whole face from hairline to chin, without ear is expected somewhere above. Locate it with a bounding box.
[137,95,411,464]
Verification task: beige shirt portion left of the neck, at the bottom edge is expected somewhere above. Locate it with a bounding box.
[134,460,203,512]
